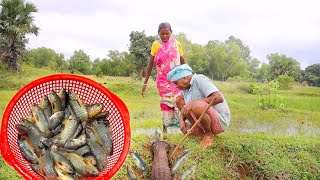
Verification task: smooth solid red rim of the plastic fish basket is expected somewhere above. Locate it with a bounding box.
[0,74,131,179]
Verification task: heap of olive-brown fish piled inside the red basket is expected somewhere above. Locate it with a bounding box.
[15,88,113,179]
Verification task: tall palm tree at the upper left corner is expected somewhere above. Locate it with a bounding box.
[0,0,39,70]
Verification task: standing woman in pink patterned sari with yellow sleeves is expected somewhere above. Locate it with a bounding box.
[141,22,186,132]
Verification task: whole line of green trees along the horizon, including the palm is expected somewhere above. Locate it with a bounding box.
[0,0,320,86]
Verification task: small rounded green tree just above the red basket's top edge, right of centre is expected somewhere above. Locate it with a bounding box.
[69,50,91,74]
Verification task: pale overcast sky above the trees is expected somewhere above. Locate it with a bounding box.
[27,0,320,69]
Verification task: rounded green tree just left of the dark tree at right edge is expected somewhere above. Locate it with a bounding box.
[267,53,300,79]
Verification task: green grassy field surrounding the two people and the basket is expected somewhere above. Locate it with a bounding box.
[0,66,320,179]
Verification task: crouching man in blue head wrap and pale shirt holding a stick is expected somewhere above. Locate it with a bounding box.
[167,64,230,148]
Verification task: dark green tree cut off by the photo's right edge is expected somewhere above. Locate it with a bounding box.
[305,64,320,86]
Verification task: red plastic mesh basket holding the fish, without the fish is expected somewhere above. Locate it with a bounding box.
[0,74,130,180]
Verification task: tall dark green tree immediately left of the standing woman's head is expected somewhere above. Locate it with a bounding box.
[129,31,155,77]
